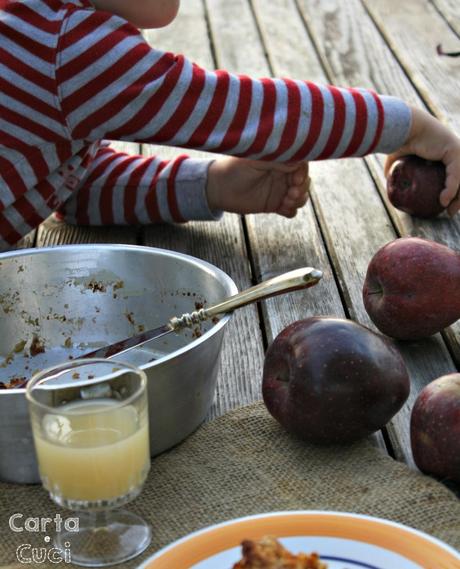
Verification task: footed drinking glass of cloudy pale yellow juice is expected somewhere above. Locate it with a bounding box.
[26,359,151,567]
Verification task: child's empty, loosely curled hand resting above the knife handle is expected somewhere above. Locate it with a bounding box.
[207,157,310,217]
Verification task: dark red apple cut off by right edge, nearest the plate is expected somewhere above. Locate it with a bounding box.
[410,373,460,483]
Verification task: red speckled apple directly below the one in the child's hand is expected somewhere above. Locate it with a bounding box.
[363,237,460,340]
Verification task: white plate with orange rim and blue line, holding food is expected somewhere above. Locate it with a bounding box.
[138,511,460,569]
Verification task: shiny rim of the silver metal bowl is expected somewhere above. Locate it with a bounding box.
[0,243,238,396]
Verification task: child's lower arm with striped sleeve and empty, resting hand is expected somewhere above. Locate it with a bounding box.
[58,146,308,225]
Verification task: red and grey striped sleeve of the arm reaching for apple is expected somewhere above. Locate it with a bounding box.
[57,9,410,161]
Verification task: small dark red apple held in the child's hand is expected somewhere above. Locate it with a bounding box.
[387,155,446,217]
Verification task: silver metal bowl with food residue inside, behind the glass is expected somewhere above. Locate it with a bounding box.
[0,245,237,483]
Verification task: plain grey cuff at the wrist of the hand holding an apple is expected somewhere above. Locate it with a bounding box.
[373,95,412,154]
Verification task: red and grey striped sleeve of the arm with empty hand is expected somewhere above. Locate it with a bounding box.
[58,146,221,225]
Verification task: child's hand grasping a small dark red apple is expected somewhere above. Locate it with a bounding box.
[385,108,460,216]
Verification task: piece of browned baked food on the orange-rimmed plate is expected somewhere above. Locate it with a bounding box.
[233,536,327,569]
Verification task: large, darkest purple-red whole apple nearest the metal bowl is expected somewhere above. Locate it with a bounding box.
[262,316,410,444]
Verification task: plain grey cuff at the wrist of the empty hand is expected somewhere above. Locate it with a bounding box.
[175,158,223,221]
